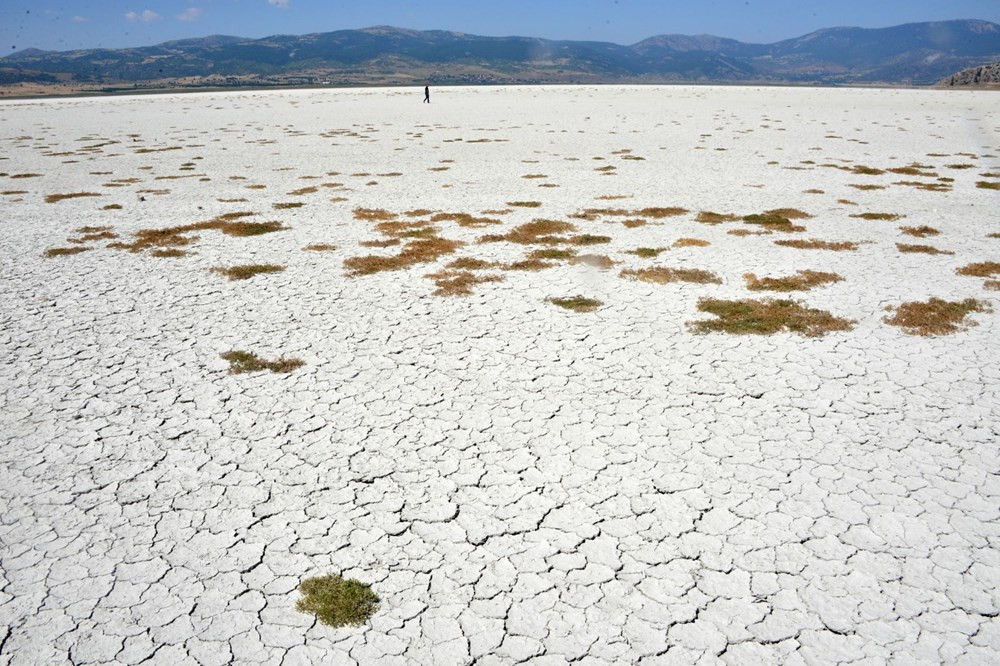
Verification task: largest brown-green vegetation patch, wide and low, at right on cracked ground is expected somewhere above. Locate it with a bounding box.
[689,298,854,337]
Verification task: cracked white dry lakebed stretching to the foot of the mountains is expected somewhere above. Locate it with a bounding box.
[0,87,1000,665]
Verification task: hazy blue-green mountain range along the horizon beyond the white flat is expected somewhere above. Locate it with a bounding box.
[0,20,1000,89]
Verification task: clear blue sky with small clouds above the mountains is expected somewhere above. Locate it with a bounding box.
[0,0,1000,54]
